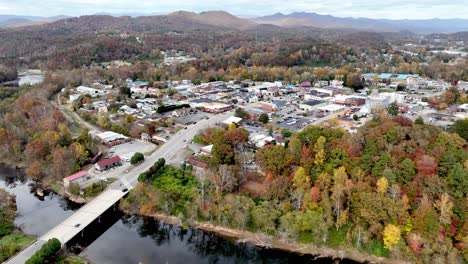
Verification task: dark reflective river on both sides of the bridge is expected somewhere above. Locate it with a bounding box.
[0,166,354,264]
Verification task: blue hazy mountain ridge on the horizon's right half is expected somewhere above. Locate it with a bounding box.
[254,12,468,34]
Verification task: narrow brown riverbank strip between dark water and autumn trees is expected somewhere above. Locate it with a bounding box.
[124,210,411,264]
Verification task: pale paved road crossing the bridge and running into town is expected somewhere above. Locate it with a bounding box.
[6,108,234,264]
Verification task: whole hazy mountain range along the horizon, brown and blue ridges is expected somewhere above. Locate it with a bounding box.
[0,11,468,34]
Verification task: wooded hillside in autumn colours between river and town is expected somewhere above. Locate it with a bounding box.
[122,115,468,263]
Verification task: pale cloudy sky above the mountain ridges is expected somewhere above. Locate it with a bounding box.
[0,0,468,19]
